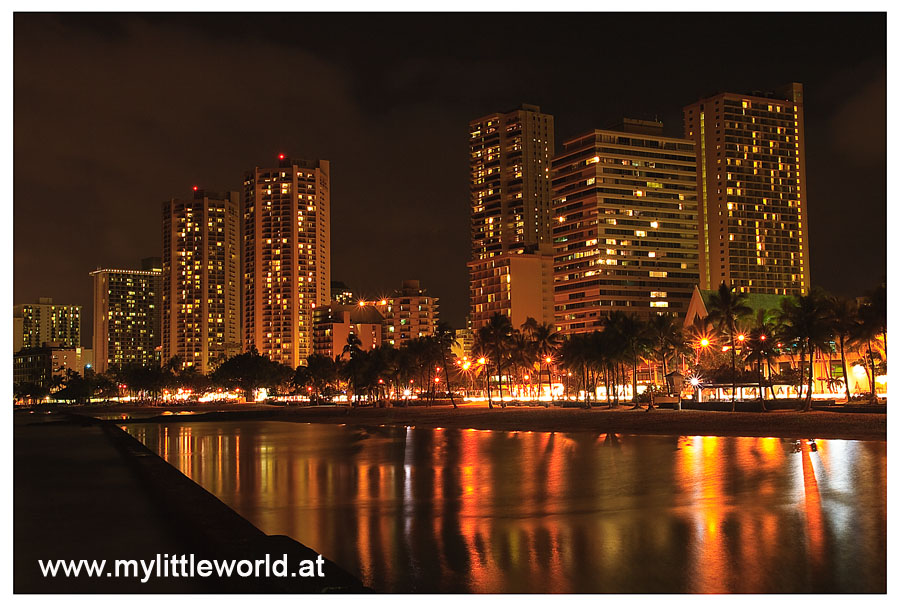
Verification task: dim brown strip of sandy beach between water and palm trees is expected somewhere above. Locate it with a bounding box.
[72,404,887,440]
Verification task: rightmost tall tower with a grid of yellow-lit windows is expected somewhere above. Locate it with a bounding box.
[684,82,809,295]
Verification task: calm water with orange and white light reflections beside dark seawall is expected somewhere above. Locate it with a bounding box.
[126,420,887,593]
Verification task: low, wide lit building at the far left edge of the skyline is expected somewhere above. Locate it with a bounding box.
[13,297,81,352]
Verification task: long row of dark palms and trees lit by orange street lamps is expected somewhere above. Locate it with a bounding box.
[15,283,887,410]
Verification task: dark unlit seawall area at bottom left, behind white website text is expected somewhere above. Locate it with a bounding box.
[13,413,366,593]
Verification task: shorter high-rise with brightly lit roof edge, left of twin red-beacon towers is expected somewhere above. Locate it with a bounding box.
[90,257,162,372]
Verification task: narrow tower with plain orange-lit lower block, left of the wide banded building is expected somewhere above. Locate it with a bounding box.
[468,105,554,329]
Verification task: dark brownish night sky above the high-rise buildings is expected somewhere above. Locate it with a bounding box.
[14,13,886,345]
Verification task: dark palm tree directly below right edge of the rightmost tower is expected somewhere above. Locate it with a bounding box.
[779,290,831,412]
